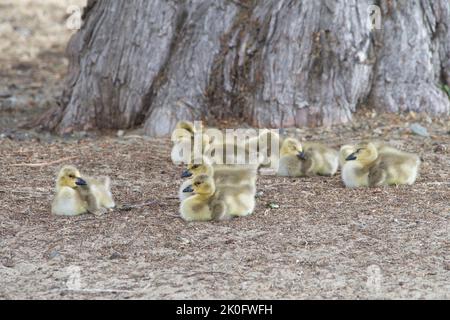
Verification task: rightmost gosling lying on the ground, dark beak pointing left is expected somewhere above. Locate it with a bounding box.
[342,142,420,188]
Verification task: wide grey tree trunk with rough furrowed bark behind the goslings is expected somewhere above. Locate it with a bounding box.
[38,0,450,136]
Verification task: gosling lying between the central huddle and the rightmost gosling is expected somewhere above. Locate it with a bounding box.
[278,138,339,177]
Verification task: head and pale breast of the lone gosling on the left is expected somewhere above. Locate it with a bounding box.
[52,166,88,216]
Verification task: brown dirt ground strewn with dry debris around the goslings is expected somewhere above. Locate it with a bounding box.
[0,0,450,299]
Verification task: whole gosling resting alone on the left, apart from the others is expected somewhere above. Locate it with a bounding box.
[52,166,115,216]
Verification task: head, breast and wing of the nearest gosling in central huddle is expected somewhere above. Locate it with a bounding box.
[180,174,226,221]
